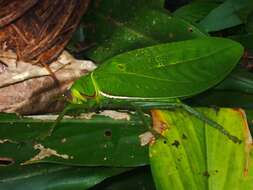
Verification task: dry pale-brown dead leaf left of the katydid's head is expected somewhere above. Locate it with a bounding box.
[0,51,96,115]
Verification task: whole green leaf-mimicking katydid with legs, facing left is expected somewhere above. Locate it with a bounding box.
[52,37,243,142]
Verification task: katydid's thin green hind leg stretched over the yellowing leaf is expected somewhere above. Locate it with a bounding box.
[131,102,241,143]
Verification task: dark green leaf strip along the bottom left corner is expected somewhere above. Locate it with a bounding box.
[0,164,131,190]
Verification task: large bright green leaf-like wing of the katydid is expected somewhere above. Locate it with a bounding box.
[92,38,243,98]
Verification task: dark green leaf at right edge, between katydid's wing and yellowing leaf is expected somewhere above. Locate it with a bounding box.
[186,67,253,109]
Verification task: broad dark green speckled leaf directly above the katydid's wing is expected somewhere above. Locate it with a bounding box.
[84,0,206,62]
